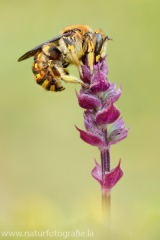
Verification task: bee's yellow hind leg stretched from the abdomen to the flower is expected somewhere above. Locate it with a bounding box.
[48,60,88,88]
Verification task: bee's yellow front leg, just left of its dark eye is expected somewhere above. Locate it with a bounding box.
[83,33,94,72]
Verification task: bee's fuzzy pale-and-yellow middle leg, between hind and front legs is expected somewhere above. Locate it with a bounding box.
[60,37,83,77]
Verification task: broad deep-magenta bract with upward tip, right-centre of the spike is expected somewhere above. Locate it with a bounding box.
[96,100,120,126]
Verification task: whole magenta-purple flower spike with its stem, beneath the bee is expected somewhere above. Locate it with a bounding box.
[76,53,129,219]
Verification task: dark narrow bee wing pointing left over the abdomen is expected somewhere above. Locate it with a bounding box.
[18,31,72,62]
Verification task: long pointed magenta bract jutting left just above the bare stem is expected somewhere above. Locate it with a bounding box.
[75,126,105,150]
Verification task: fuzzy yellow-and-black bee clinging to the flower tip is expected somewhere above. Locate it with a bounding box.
[18,25,111,92]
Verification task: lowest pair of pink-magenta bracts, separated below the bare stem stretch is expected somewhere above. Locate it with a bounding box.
[91,159,123,191]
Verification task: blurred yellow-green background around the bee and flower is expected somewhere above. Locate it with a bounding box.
[0,0,160,240]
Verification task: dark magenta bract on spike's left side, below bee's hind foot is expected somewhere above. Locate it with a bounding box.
[76,91,101,109]
